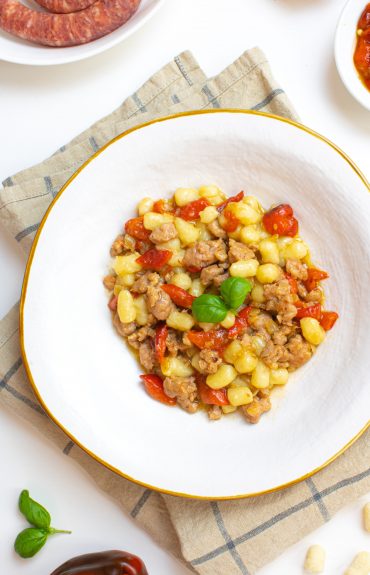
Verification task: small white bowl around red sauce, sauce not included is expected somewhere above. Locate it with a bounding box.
[335,0,370,110]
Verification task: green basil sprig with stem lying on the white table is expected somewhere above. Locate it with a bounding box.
[14,489,71,558]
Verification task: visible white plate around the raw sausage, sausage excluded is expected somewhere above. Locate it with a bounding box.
[0,0,164,66]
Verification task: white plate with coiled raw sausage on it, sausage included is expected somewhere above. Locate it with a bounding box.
[0,0,164,66]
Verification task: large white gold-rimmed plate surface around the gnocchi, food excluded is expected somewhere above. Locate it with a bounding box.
[21,110,370,498]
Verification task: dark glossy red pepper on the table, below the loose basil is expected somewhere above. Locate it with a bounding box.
[51,551,148,575]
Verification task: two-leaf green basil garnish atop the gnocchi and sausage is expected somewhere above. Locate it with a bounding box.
[192,278,252,323]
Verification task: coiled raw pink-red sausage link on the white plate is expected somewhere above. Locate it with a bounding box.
[0,0,141,46]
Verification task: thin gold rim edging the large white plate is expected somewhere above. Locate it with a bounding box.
[19,108,370,501]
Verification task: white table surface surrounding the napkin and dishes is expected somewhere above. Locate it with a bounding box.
[0,0,370,575]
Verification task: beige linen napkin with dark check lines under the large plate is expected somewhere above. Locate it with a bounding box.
[0,48,370,575]
